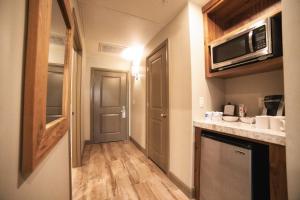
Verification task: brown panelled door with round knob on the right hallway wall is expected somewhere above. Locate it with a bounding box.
[147,43,169,172]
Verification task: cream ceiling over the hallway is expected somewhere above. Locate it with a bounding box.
[78,0,207,54]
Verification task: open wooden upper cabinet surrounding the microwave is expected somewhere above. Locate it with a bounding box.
[202,0,283,78]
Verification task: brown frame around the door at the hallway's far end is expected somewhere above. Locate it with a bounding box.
[90,67,130,143]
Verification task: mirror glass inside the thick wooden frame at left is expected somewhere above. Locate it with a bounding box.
[46,1,67,123]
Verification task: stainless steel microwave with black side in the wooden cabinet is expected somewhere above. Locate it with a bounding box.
[210,13,282,72]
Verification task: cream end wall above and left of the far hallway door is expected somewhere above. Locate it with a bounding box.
[82,53,131,140]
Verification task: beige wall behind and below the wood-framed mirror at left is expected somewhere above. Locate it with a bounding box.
[0,0,70,200]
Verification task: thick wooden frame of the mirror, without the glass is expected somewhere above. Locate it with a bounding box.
[21,0,73,177]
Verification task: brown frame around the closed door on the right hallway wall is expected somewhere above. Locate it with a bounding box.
[145,39,170,175]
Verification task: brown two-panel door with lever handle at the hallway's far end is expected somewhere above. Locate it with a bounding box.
[92,70,128,143]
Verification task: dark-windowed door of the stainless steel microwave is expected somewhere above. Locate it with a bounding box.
[212,31,253,69]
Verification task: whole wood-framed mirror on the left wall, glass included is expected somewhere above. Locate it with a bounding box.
[21,0,73,177]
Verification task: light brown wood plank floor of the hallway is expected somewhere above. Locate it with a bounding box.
[72,142,188,200]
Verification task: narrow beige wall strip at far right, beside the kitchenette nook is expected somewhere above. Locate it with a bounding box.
[282,0,300,200]
